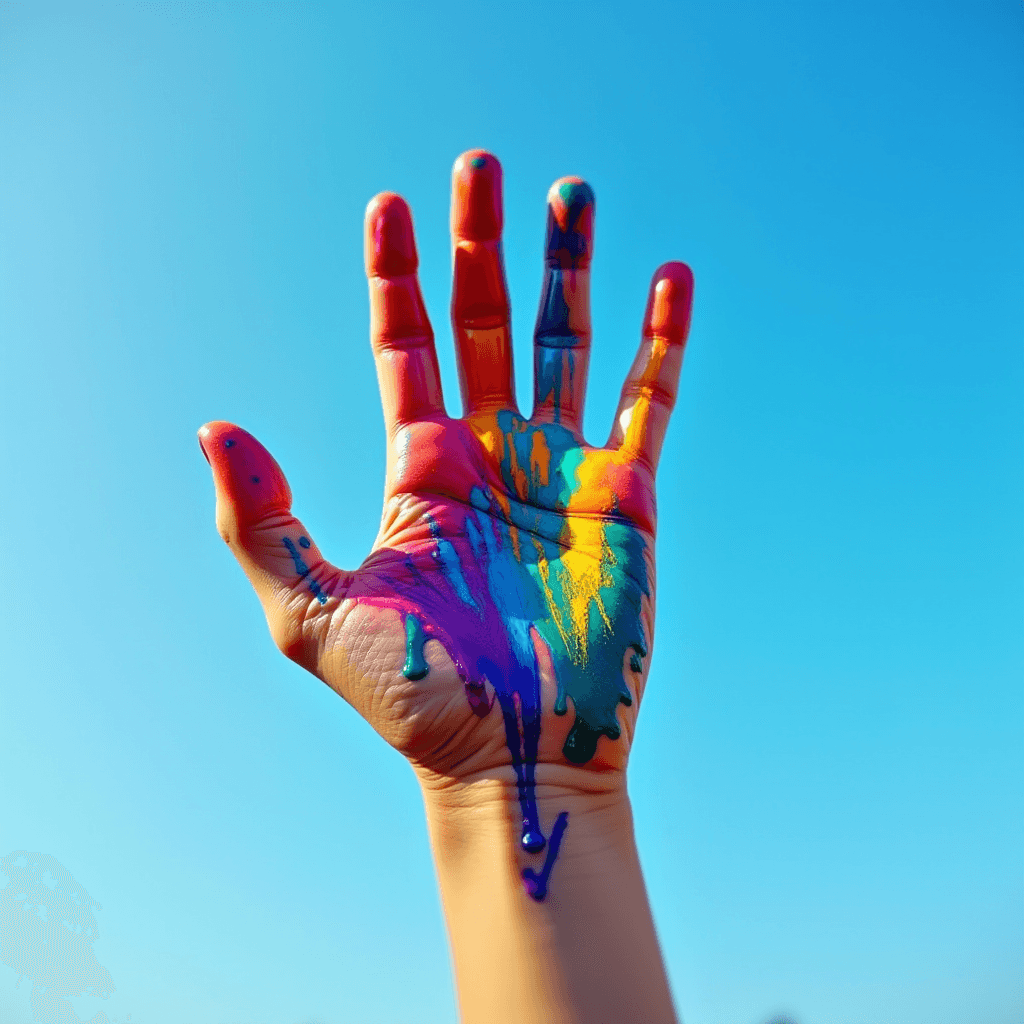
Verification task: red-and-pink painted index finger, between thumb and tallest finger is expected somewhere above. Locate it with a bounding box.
[365,193,444,433]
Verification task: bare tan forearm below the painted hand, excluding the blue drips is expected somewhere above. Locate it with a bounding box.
[415,779,676,1024]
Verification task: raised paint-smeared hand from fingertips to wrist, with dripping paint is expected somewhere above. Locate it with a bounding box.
[200,151,692,899]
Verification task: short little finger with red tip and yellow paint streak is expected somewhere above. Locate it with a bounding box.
[608,262,693,468]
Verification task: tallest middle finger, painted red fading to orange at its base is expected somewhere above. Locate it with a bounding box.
[452,150,515,416]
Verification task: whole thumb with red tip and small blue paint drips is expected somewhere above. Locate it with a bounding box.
[199,422,347,669]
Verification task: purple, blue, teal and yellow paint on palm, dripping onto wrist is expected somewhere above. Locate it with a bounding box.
[327,410,649,899]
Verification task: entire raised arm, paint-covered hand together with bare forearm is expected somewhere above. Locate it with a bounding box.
[200,151,693,1024]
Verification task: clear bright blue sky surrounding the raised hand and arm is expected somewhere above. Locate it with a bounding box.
[0,0,1024,1024]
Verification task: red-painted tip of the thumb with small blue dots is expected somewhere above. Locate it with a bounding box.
[199,420,292,519]
